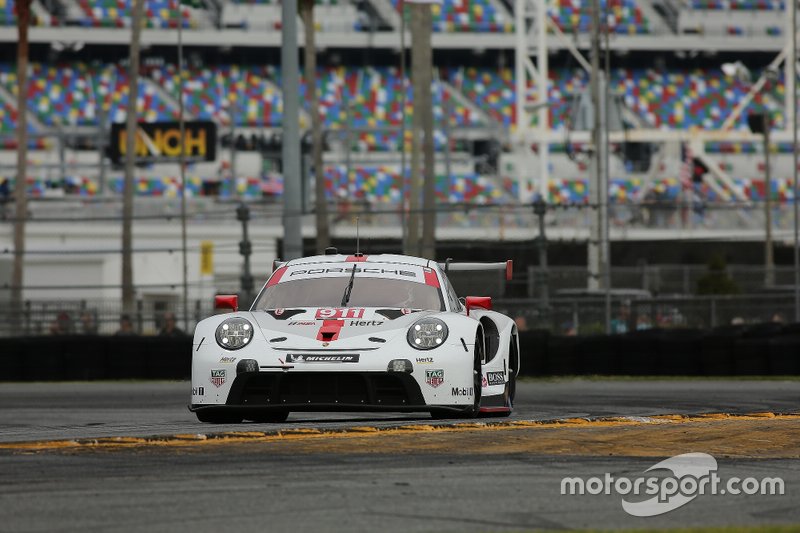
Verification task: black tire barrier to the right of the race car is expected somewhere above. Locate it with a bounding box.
[520,322,800,376]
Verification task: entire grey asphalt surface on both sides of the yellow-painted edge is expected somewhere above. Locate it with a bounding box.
[0,380,800,532]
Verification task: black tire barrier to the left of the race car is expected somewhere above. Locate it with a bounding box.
[0,335,192,381]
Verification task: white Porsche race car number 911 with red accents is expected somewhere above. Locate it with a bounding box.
[189,252,520,423]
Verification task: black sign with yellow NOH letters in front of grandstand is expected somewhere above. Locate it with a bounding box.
[109,121,217,163]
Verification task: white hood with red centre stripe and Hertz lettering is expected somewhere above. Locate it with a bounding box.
[253,307,436,349]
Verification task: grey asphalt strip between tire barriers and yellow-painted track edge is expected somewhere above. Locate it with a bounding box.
[0,380,800,442]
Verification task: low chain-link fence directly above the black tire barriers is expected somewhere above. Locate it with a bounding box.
[0,290,795,337]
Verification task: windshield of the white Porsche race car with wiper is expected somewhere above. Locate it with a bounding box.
[255,272,444,311]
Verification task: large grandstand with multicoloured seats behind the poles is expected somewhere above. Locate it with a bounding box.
[0,0,793,308]
